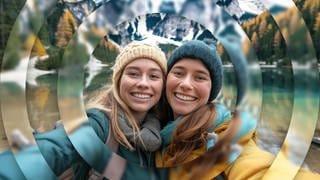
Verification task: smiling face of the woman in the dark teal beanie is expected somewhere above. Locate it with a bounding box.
[166,58,211,118]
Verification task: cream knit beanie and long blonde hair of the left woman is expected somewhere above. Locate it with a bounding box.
[88,41,167,150]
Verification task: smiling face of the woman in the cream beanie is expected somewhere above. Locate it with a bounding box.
[119,58,164,117]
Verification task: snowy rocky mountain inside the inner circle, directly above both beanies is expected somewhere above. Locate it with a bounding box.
[108,13,216,46]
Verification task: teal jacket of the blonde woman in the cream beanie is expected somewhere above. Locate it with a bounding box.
[0,109,167,180]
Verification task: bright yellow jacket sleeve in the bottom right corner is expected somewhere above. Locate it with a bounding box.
[225,141,320,180]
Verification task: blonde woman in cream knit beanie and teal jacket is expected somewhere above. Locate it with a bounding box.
[0,41,167,180]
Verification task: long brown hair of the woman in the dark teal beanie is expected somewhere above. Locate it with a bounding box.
[162,103,240,176]
